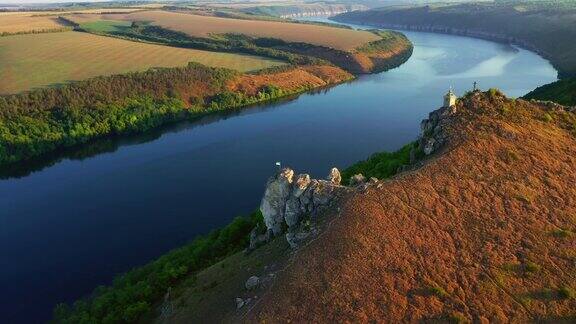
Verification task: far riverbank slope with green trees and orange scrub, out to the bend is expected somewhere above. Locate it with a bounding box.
[0,34,412,170]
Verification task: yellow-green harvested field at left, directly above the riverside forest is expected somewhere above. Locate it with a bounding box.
[0,32,284,94]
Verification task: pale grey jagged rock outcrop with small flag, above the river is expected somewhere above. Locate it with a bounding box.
[255,168,350,239]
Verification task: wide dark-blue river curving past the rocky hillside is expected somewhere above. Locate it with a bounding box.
[0,18,556,323]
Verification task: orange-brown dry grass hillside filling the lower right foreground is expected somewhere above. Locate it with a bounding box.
[251,92,576,323]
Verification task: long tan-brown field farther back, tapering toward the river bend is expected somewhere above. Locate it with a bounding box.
[92,10,379,51]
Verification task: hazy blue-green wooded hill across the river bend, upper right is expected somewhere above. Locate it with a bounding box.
[334,0,576,77]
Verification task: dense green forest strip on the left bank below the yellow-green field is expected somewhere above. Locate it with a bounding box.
[0,63,302,165]
